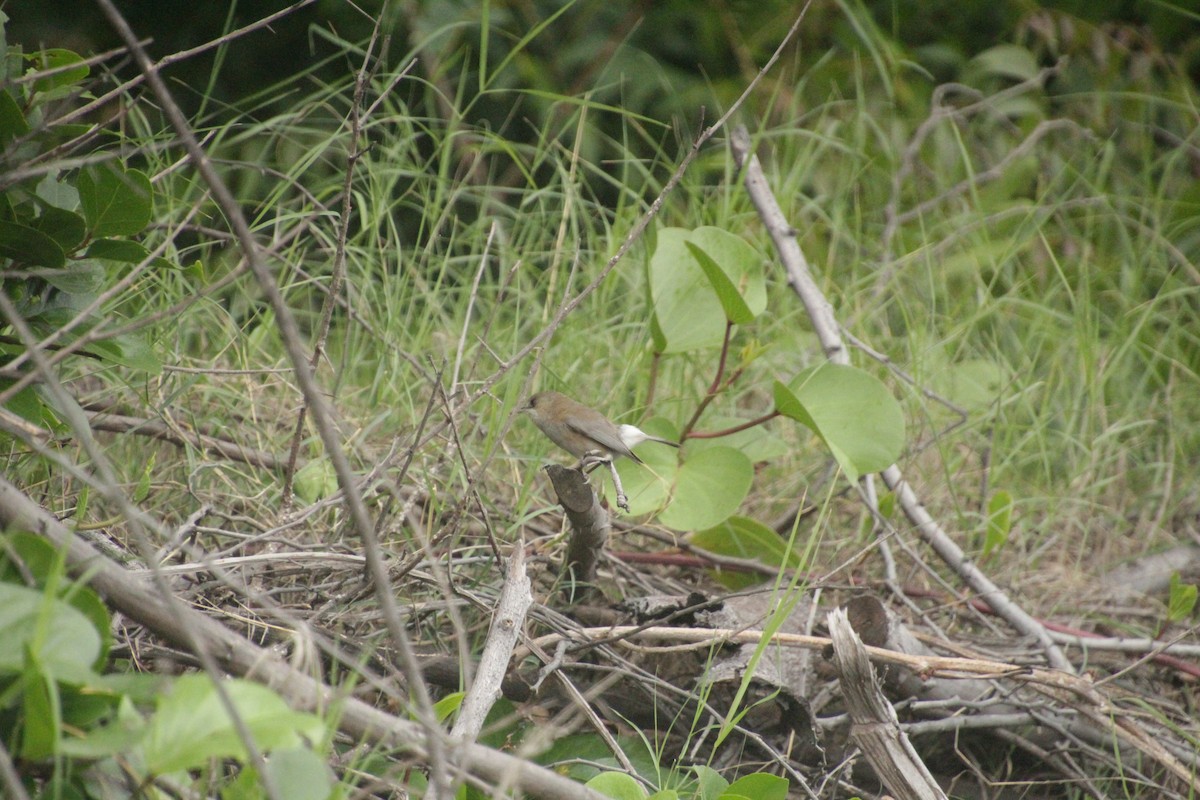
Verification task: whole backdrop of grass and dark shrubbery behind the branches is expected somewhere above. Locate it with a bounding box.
[0,1,1200,796]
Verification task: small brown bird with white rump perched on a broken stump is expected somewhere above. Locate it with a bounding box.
[521,392,679,467]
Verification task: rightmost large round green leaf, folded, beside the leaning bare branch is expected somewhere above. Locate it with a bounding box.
[775,363,905,481]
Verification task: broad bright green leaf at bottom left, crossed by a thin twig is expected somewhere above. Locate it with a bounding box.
[138,674,324,775]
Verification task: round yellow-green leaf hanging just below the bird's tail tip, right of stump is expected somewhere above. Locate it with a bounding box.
[659,447,754,530]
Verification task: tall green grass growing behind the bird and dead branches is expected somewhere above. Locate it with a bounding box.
[4,3,1200,796]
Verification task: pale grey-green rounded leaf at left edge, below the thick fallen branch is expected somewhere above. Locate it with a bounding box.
[0,583,102,676]
